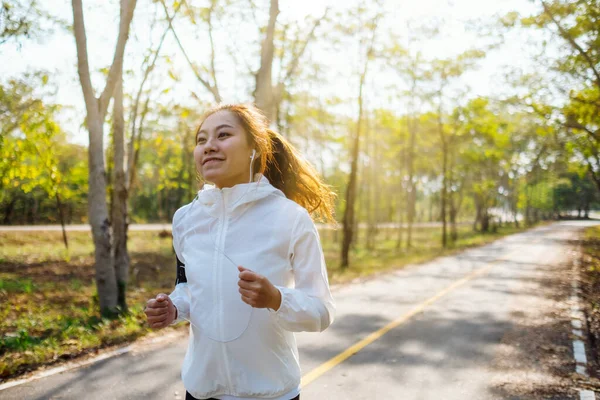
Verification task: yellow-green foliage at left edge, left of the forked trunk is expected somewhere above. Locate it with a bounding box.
[0,74,87,223]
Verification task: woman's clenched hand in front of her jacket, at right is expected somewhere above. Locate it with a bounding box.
[238,266,281,311]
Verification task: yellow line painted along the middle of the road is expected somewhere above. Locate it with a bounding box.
[300,251,516,387]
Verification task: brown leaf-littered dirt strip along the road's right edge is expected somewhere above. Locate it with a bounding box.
[494,242,600,400]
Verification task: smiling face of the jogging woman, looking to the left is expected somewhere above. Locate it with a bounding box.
[194,110,252,188]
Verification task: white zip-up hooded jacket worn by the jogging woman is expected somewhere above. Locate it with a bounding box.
[170,175,335,399]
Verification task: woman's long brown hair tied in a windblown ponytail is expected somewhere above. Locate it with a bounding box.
[198,104,335,222]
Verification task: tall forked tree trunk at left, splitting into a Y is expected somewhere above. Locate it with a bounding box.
[72,0,136,315]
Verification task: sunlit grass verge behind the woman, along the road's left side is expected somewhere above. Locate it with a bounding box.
[0,220,536,379]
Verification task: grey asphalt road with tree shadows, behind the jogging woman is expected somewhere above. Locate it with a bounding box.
[0,222,598,400]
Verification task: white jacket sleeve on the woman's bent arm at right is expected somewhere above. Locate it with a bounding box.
[268,210,335,332]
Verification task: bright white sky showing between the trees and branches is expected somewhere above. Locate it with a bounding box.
[0,0,535,144]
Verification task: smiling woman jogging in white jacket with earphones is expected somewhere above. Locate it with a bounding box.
[145,105,335,400]
